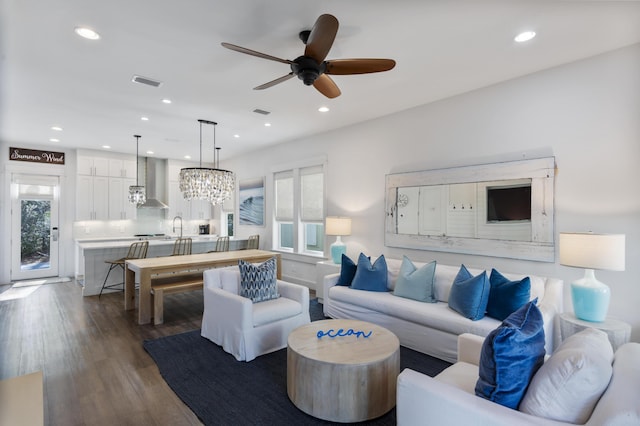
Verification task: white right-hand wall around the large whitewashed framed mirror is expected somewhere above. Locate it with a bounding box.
[224,45,640,341]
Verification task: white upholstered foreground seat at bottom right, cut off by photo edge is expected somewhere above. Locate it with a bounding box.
[396,334,640,426]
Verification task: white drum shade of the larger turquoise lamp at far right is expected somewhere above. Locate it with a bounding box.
[559,233,625,271]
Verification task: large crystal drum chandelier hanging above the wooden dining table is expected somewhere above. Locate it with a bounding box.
[180,120,236,206]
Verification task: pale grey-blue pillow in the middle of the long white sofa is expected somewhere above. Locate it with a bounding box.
[393,256,436,303]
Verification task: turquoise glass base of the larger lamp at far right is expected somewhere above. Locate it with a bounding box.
[571,269,611,322]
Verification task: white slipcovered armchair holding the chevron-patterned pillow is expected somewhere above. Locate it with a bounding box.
[201,267,310,362]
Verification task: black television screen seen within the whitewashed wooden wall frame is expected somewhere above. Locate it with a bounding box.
[487,184,531,223]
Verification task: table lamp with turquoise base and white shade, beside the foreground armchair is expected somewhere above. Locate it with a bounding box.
[559,232,625,322]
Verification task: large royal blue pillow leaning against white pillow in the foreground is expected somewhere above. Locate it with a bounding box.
[475,299,545,410]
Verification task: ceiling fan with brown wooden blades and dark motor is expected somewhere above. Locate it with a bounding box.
[222,14,396,98]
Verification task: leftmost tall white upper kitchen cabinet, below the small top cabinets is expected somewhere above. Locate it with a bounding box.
[76,175,109,220]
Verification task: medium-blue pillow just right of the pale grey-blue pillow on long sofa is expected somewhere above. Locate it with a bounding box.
[449,265,490,321]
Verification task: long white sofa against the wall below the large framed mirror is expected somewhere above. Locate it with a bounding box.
[322,259,563,363]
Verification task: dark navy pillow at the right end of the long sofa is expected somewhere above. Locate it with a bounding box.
[487,269,531,321]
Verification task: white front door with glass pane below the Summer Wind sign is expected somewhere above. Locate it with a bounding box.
[11,175,58,281]
